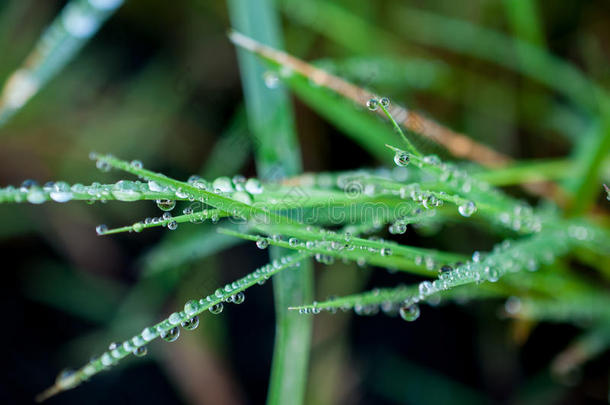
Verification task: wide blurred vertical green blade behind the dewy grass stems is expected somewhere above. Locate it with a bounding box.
[228,0,313,405]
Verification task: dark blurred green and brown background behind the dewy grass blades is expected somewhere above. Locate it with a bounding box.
[0,0,610,405]
